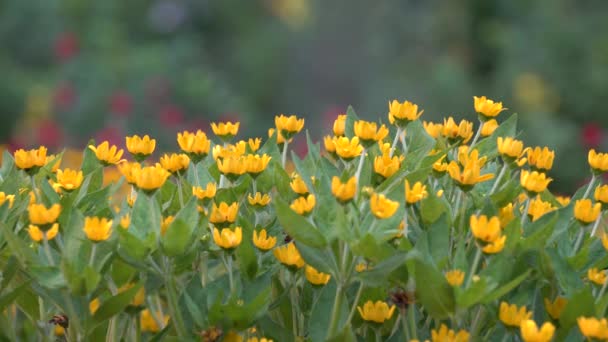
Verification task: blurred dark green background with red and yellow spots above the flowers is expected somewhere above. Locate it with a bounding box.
[0,0,608,194]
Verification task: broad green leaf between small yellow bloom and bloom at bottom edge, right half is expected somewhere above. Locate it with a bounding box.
[412,258,456,319]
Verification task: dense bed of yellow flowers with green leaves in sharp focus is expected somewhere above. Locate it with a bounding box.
[0,97,608,341]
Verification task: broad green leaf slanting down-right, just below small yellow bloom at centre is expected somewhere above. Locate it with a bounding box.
[274,197,327,247]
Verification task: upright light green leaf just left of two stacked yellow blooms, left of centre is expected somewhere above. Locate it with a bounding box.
[160,196,198,257]
